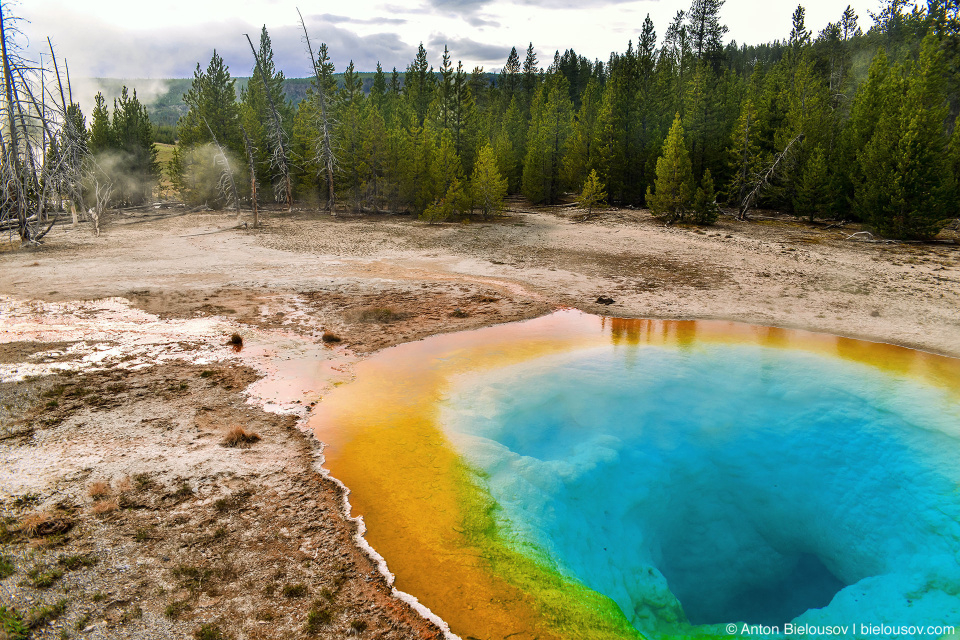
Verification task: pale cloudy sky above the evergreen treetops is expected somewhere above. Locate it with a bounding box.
[18,0,880,78]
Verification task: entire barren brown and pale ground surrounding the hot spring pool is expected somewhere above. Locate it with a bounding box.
[0,203,960,640]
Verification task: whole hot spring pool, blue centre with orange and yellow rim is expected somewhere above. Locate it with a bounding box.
[312,312,960,638]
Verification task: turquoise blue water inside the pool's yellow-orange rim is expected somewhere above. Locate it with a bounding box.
[441,345,960,637]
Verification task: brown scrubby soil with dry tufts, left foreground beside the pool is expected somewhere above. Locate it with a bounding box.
[2,364,440,639]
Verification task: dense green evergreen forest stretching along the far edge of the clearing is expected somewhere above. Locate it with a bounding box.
[154,0,960,238]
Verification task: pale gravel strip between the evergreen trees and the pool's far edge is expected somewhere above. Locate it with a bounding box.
[0,208,960,356]
